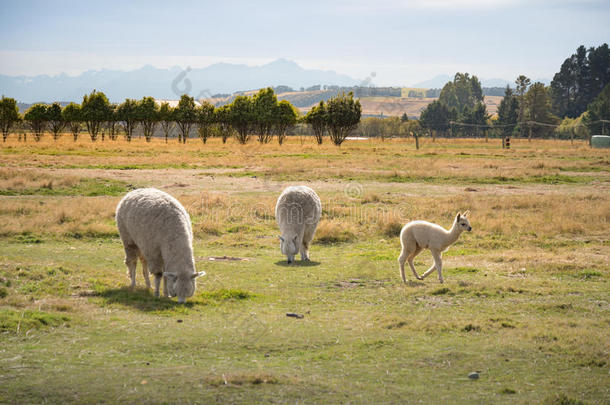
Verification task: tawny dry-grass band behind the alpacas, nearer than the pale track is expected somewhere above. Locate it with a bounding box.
[0,181,610,242]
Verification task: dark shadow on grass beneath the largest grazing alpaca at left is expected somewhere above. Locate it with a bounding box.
[94,287,193,312]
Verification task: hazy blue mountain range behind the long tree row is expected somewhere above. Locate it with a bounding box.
[0,59,359,103]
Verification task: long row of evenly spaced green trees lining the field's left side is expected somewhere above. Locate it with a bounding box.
[0,88,361,145]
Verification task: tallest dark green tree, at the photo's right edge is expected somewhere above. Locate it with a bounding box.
[551,44,610,118]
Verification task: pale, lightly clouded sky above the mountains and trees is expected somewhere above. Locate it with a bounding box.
[0,0,610,86]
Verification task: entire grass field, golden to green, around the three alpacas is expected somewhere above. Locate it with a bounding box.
[0,136,610,404]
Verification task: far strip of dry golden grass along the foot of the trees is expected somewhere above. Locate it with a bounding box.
[0,138,610,181]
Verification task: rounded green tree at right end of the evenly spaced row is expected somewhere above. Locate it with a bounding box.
[326,92,362,146]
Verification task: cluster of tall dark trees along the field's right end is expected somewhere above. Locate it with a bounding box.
[420,44,610,139]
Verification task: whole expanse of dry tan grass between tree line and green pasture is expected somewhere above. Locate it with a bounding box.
[0,138,610,244]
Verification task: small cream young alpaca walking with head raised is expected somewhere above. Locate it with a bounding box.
[398,211,472,283]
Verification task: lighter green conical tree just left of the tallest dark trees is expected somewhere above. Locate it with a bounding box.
[525,82,559,141]
